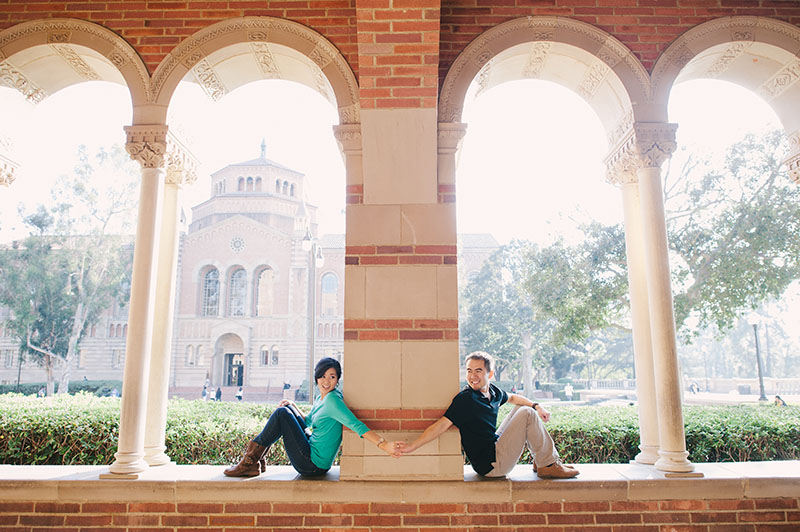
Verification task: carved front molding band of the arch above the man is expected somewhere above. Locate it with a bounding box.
[439,16,651,122]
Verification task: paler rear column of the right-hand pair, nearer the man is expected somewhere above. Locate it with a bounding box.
[606,144,659,465]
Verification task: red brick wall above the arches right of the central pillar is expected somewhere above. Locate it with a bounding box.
[439,0,800,82]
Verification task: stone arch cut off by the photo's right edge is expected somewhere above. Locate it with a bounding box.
[643,16,800,135]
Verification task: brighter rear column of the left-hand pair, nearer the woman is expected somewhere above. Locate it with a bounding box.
[144,135,197,466]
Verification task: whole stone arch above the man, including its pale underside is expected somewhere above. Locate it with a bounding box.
[439,17,650,144]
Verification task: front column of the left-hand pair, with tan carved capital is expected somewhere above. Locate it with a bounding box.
[106,125,167,478]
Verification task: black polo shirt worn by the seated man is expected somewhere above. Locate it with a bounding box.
[444,383,508,475]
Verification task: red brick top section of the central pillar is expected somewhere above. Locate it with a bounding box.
[356,0,440,109]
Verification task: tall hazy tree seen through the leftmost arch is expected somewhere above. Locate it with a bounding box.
[0,146,138,394]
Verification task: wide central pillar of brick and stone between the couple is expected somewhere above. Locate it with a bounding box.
[341,0,463,479]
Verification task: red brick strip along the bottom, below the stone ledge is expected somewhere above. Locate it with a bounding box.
[0,496,800,532]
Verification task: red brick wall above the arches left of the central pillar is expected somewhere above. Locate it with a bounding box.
[0,0,358,74]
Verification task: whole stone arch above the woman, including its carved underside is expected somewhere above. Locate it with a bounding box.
[152,17,359,124]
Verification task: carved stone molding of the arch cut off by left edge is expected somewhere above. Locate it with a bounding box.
[0,18,150,106]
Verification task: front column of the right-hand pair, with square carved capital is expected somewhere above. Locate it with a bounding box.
[634,122,694,472]
